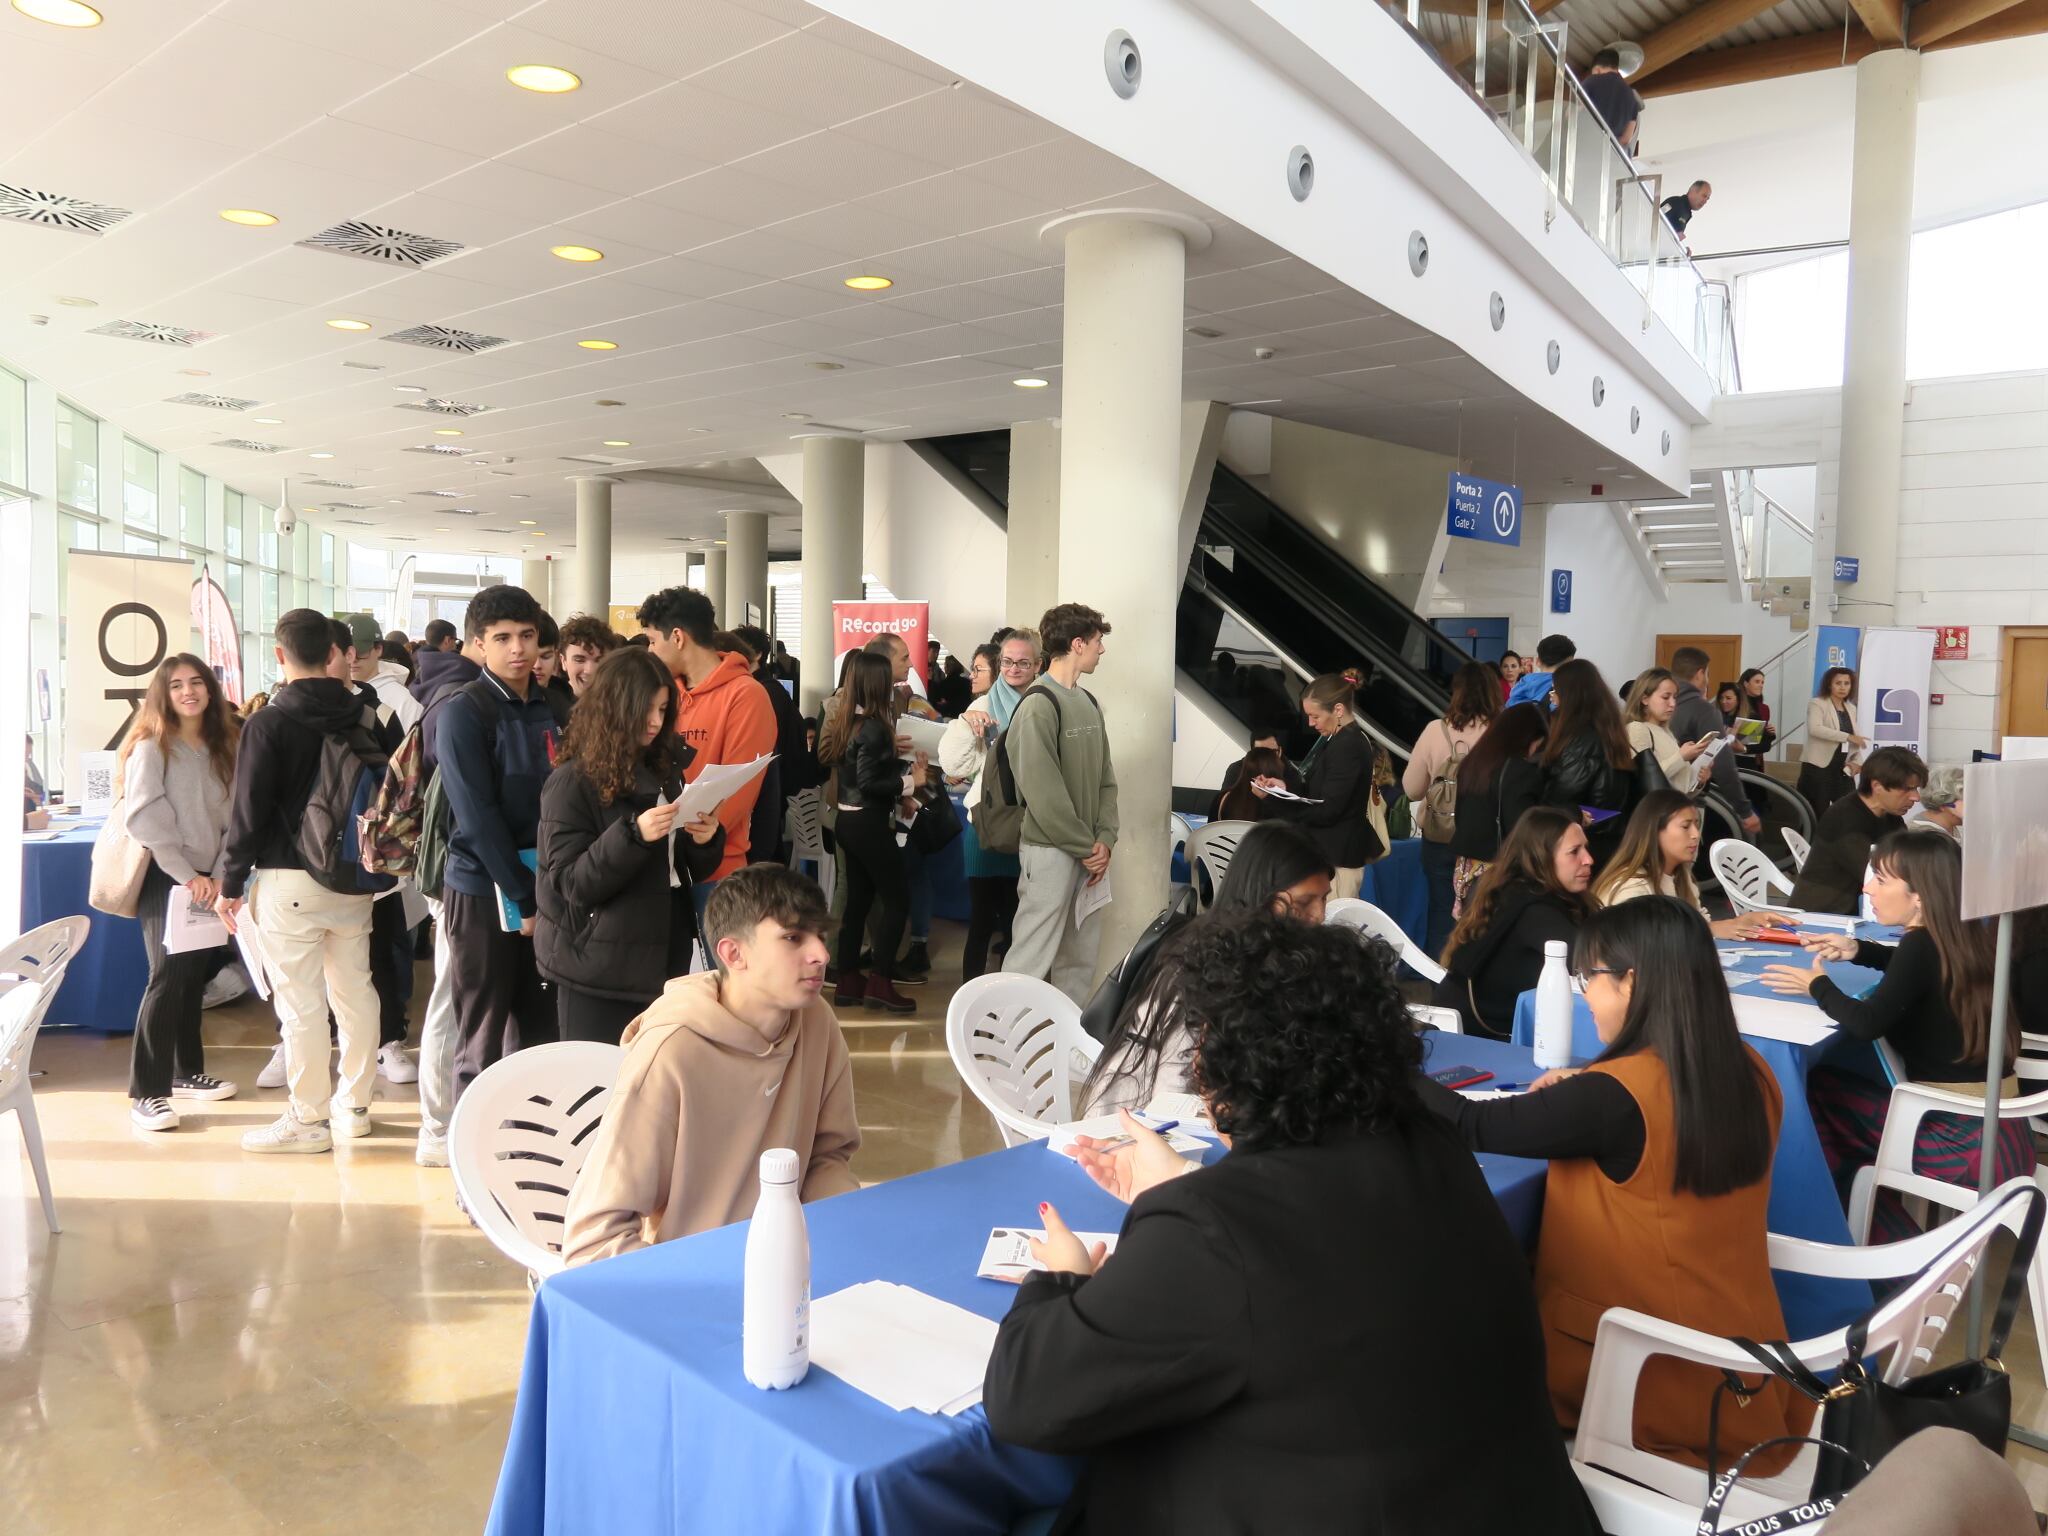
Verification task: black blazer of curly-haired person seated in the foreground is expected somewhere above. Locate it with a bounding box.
[983,1100,1599,1536]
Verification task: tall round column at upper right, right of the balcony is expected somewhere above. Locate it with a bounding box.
[1812,47,1921,625]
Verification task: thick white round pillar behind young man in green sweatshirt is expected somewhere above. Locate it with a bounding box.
[1053,213,1208,969]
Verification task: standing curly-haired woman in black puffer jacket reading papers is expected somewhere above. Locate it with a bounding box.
[532,647,725,1044]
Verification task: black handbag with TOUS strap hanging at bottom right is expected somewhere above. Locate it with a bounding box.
[1726,1186,2048,1497]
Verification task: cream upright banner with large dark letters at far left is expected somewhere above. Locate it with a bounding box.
[63,549,193,801]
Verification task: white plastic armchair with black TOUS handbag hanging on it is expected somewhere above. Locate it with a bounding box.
[1571,1180,2038,1536]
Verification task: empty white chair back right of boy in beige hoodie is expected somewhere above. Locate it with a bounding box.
[946,971,1102,1147]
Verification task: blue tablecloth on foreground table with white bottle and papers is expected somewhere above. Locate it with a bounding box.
[487,1073,1542,1536]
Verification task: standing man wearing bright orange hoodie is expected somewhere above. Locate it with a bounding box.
[635,586,774,901]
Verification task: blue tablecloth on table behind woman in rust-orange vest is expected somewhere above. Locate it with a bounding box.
[1507,930,1878,1339]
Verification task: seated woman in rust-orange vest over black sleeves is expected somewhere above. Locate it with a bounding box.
[1415,895,1806,1466]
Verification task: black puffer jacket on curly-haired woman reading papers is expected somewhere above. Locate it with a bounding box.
[532,762,725,1001]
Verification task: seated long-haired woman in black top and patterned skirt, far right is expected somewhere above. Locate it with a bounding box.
[1763,831,2034,1243]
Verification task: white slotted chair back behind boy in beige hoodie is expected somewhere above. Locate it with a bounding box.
[449,1040,627,1278]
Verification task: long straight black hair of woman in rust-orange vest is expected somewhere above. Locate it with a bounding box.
[1571,901,1785,1196]
